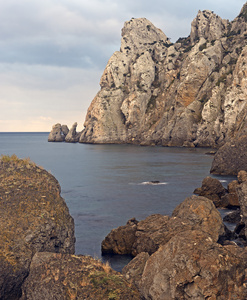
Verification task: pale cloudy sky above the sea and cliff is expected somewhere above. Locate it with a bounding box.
[0,0,246,132]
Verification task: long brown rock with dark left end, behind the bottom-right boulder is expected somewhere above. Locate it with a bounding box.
[102,196,225,256]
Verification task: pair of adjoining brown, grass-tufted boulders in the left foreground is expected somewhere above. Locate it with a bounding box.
[0,156,140,300]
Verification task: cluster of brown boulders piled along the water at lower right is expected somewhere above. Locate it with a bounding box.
[102,171,247,300]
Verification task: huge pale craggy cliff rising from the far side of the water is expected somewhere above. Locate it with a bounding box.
[51,3,247,147]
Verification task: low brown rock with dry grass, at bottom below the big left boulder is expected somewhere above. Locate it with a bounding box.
[21,252,140,300]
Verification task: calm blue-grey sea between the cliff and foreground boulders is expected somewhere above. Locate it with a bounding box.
[0,133,233,271]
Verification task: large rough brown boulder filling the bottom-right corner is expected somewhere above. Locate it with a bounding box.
[140,230,247,300]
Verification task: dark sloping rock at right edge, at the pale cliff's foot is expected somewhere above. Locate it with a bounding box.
[210,134,247,175]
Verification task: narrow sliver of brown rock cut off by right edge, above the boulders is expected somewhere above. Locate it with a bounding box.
[237,171,247,239]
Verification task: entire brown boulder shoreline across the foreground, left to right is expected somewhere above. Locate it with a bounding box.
[0,156,247,300]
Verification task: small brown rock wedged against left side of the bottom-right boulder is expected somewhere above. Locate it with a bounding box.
[122,252,150,290]
